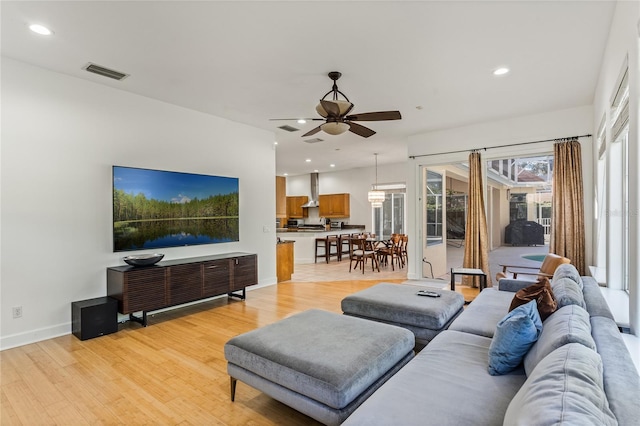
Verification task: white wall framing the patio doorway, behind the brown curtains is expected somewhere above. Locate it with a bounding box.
[407,106,593,279]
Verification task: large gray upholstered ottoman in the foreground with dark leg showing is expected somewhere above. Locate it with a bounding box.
[224,309,414,425]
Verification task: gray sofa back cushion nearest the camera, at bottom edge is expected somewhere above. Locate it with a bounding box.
[503,343,616,426]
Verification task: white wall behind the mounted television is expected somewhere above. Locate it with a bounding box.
[0,58,276,349]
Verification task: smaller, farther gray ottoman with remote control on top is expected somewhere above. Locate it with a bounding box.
[342,283,464,346]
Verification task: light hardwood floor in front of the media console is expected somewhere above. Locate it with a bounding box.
[0,279,477,426]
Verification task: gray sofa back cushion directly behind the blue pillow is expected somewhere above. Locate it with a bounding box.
[524,305,596,376]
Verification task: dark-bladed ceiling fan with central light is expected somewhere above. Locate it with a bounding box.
[272,71,402,138]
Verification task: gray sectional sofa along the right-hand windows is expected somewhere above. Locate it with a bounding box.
[343,265,640,426]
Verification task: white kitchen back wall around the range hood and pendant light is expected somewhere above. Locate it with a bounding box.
[287,163,407,231]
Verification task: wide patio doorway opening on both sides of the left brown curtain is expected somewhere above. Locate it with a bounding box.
[421,153,553,279]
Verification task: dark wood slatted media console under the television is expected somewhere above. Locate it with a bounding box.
[107,253,258,326]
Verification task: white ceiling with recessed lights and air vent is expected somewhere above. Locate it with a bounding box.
[0,0,615,175]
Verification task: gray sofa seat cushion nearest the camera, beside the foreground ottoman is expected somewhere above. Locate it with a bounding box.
[343,330,526,426]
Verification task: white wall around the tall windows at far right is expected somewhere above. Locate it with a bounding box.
[592,1,640,336]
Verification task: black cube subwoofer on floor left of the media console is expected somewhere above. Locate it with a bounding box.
[71,297,118,340]
